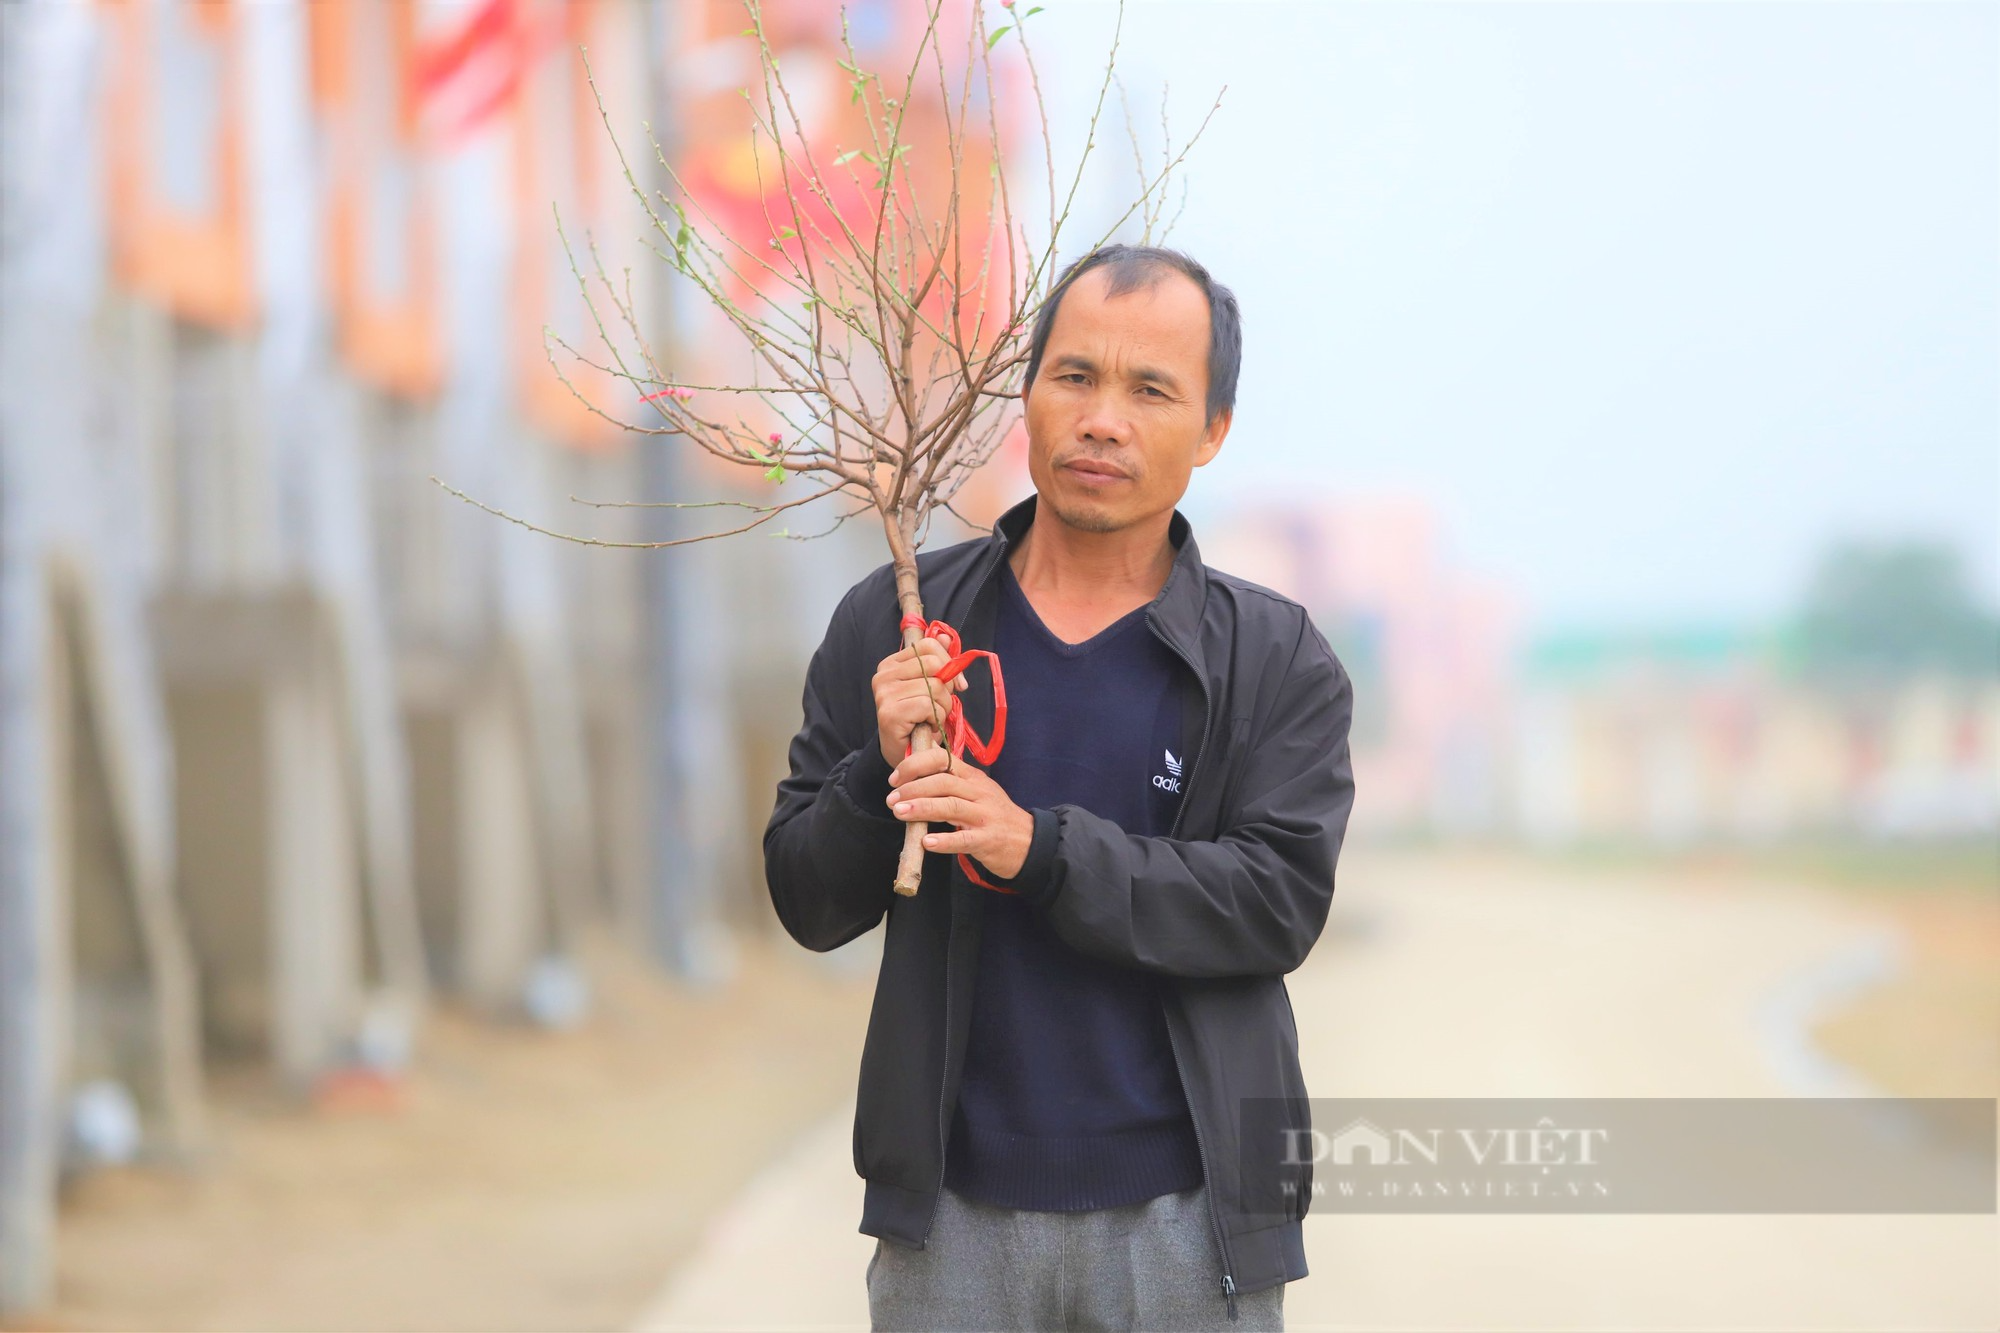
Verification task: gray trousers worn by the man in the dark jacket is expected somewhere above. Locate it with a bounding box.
[868,1185,1284,1333]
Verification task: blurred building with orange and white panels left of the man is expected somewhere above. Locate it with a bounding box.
[0,0,1016,1311]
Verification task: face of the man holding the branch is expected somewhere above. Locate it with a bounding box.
[1026,268,1230,532]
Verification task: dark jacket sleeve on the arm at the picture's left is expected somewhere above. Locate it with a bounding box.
[764,580,904,953]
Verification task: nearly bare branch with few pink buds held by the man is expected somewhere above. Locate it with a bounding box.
[432,0,1220,893]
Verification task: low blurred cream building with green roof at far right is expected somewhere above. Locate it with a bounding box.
[1516,630,2000,845]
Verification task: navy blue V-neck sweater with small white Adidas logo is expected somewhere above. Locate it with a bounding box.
[944,562,1202,1211]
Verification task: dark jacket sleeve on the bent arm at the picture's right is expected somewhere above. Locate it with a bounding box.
[998,614,1354,977]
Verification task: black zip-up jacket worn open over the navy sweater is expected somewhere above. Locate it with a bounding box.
[764,496,1354,1317]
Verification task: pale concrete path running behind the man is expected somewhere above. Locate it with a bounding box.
[636,853,2000,1333]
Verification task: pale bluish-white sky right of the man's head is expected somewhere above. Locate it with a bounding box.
[1020,0,2000,624]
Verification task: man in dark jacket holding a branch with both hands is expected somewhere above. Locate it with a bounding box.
[764,246,1354,1329]
